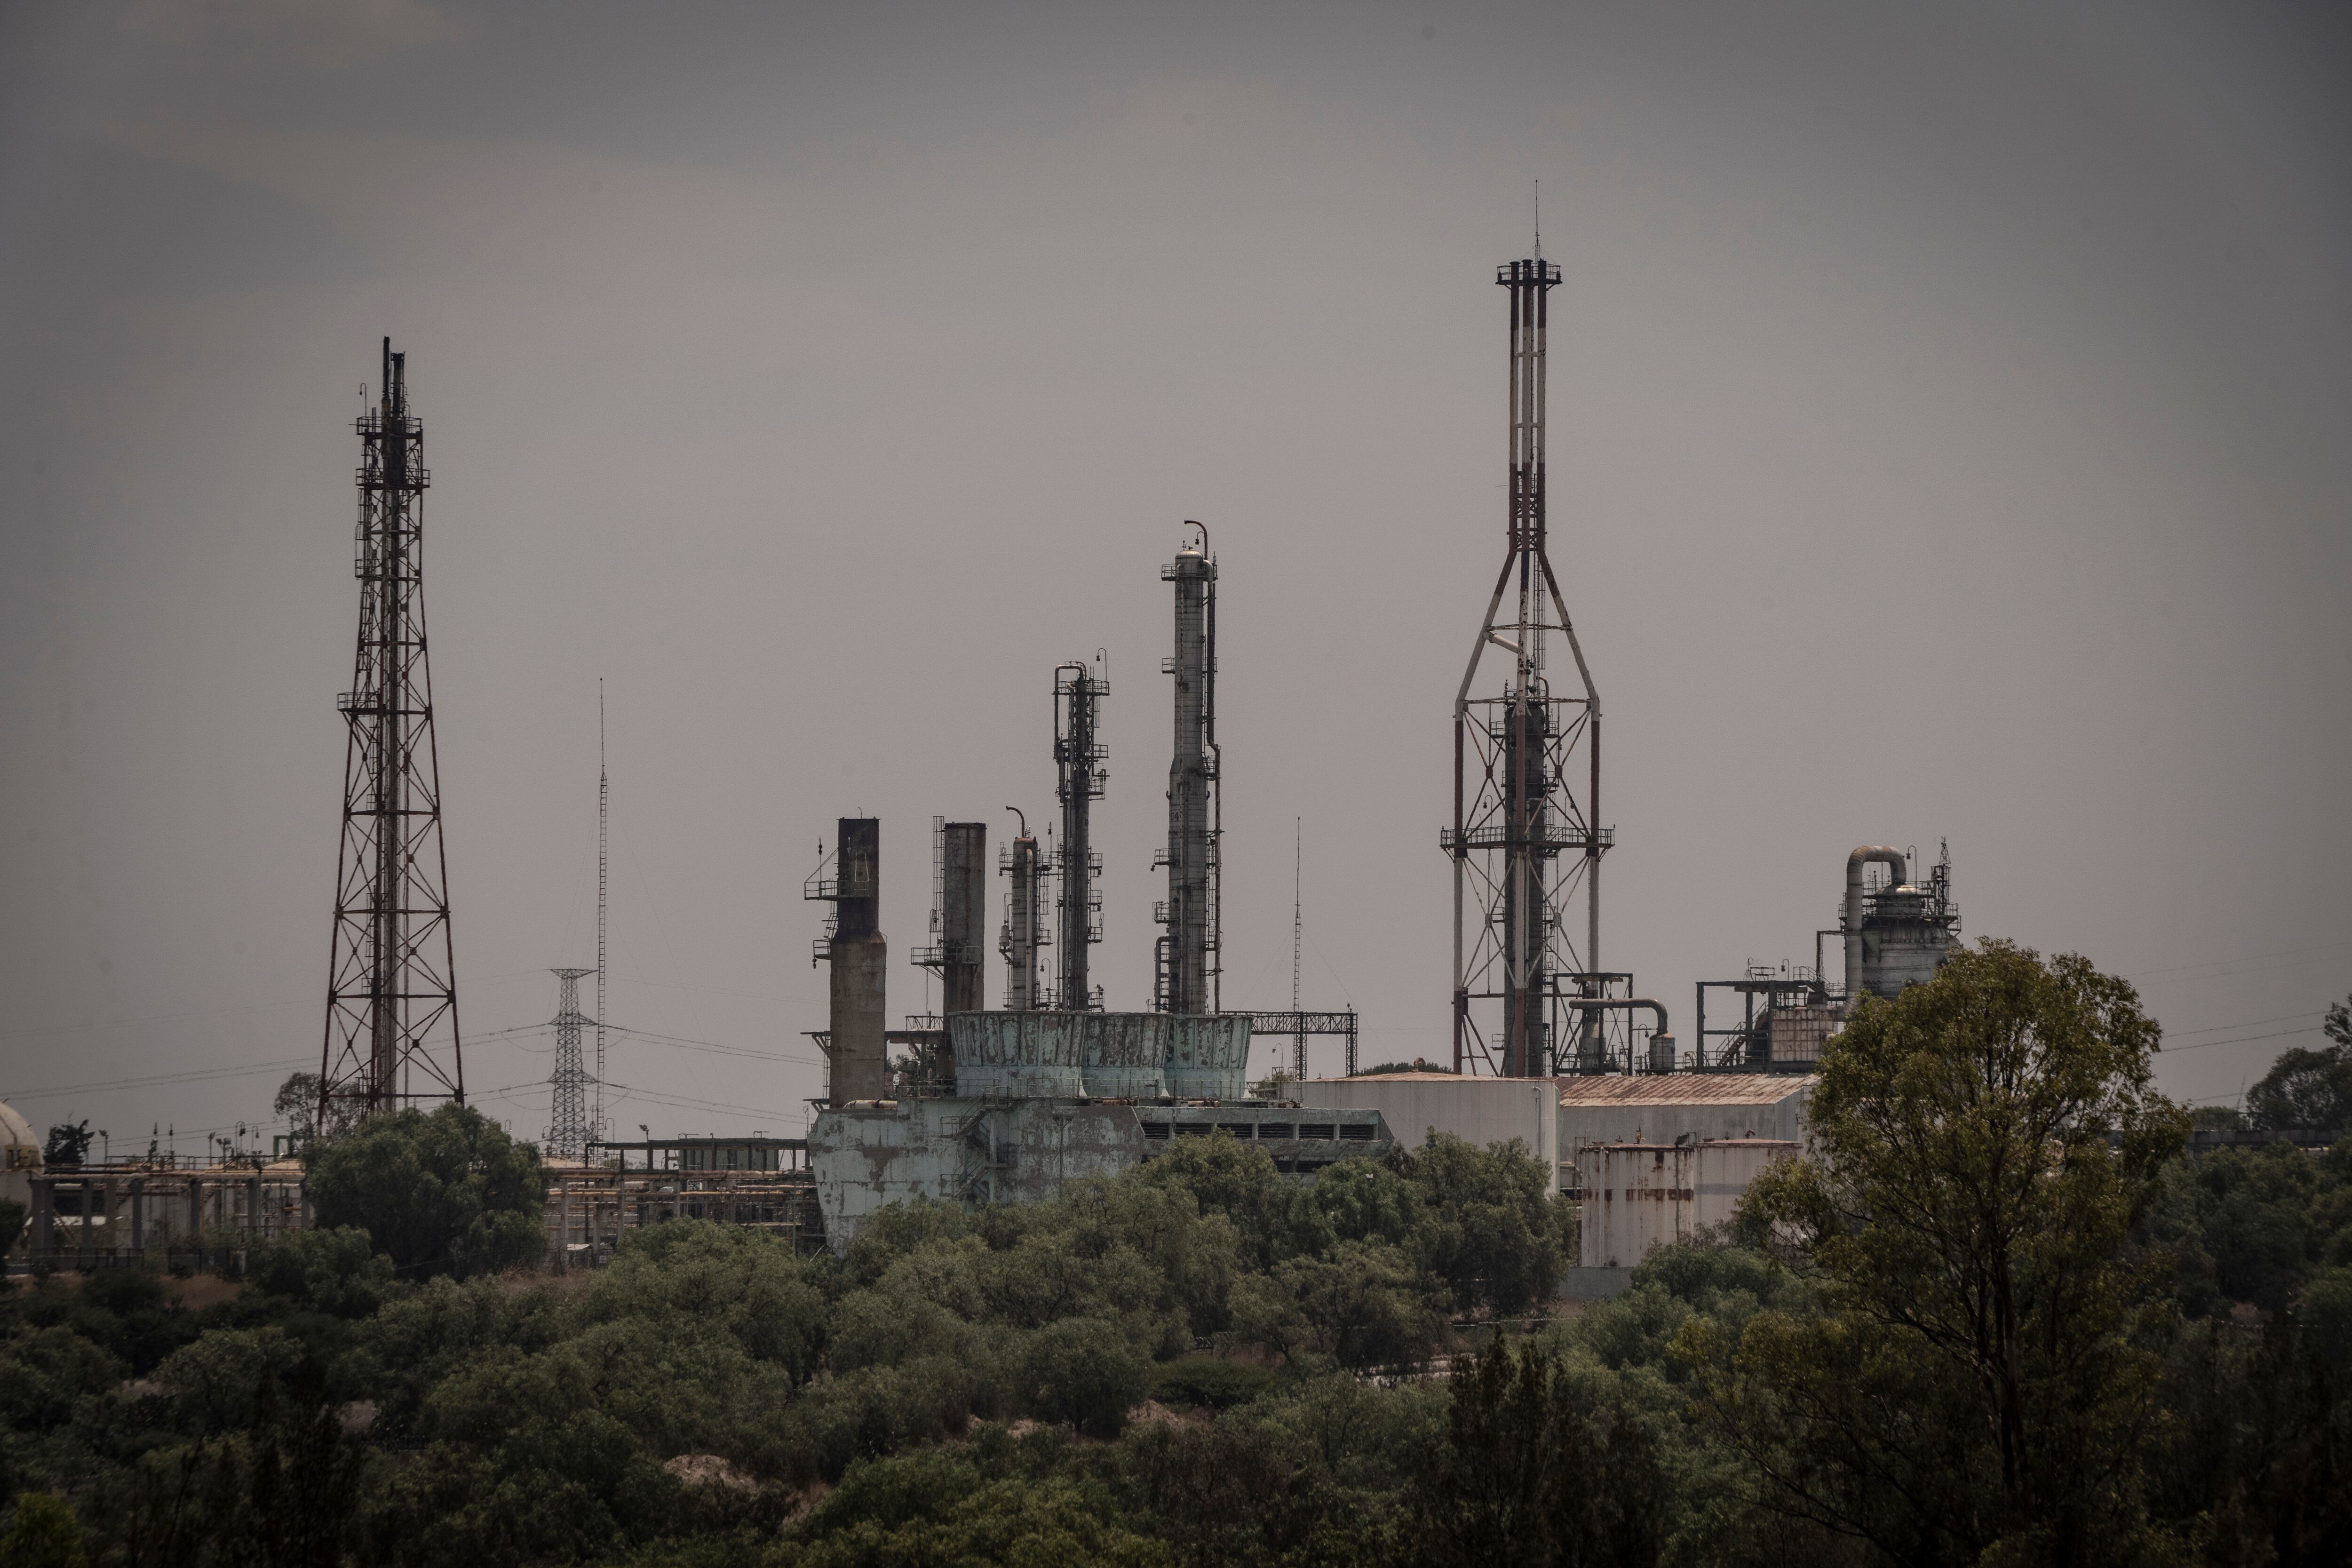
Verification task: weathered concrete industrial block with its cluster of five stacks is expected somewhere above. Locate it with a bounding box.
[804,522,1395,1248]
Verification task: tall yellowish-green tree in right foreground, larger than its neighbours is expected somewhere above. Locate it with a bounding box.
[1717,943,2187,1563]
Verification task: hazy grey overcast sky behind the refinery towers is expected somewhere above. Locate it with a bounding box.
[0,0,2352,1147]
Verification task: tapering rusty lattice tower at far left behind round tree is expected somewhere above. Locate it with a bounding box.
[318,339,466,1131]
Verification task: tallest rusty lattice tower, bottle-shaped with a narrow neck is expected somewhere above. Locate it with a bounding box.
[1439,261,1613,1077]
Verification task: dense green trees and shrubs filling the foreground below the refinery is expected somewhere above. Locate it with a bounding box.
[0,943,2352,1568]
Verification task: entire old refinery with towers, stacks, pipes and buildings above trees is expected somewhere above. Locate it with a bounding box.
[9,256,1959,1290]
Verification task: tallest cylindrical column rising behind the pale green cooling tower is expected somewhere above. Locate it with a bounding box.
[1155,522,1221,1013]
